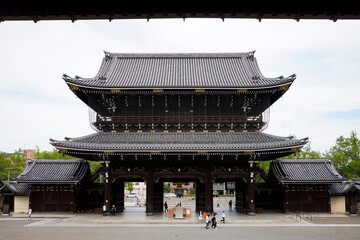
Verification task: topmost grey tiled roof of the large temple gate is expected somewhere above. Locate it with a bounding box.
[64,52,295,89]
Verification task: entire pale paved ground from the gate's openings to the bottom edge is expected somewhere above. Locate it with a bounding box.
[4,199,360,240]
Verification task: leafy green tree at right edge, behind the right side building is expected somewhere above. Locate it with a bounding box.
[325,131,360,179]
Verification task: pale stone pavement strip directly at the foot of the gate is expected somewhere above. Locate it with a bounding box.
[7,203,360,226]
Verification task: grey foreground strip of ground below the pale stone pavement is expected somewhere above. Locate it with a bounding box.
[0,216,360,240]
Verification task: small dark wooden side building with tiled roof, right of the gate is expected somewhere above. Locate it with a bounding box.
[270,159,345,212]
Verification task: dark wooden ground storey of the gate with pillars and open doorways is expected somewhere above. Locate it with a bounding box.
[101,155,258,215]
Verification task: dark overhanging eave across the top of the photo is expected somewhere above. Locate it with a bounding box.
[0,0,360,22]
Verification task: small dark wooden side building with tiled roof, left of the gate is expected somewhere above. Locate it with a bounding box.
[15,159,91,212]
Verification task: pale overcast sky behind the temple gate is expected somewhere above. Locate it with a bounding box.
[0,19,360,152]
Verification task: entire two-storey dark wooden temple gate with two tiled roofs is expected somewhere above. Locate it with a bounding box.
[50,52,307,215]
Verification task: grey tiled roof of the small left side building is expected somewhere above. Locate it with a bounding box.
[14,159,90,183]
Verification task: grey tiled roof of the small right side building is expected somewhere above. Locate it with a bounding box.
[270,159,345,183]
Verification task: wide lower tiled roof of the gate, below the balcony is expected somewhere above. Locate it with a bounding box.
[51,132,307,152]
